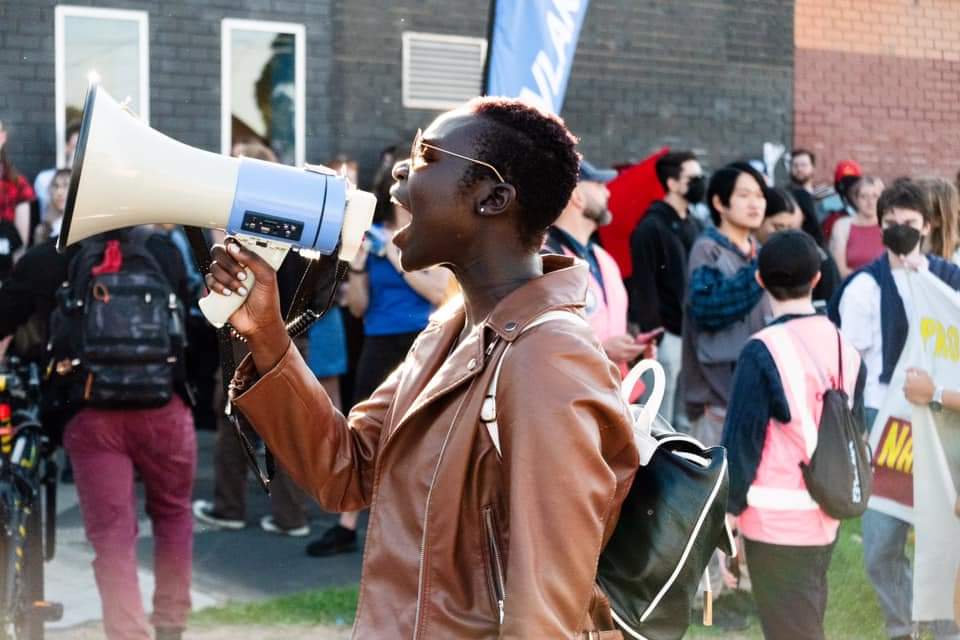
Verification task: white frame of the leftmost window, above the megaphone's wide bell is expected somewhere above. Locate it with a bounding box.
[54,4,150,167]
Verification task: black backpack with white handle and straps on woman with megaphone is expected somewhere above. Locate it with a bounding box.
[480,311,736,640]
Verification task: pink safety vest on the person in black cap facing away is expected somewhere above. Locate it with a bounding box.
[740,316,860,546]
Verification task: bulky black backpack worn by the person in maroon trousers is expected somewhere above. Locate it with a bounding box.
[47,232,186,411]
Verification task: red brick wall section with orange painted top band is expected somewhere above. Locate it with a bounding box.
[794,0,960,183]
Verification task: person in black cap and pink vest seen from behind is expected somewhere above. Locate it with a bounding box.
[723,230,866,640]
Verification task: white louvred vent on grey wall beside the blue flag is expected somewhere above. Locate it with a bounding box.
[403,31,487,109]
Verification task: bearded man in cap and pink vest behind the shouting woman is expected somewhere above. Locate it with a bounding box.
[544,160,659,382]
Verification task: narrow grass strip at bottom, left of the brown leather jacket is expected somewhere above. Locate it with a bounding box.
[191,586,358,625]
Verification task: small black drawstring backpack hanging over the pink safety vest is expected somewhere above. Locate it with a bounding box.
[800,331,873,520]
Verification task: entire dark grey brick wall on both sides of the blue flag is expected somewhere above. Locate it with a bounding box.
[0,0,793,188]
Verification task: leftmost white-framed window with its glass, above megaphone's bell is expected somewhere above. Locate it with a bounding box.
[54,5,150,166]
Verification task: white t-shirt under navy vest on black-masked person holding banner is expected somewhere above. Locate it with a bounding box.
[840,269,913,409]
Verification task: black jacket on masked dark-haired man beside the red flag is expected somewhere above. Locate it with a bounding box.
[627,200,701,336]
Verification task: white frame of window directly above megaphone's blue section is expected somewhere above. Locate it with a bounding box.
[220,18,307,167]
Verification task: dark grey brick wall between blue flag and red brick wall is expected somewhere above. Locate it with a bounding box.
[564,0,793,172]
